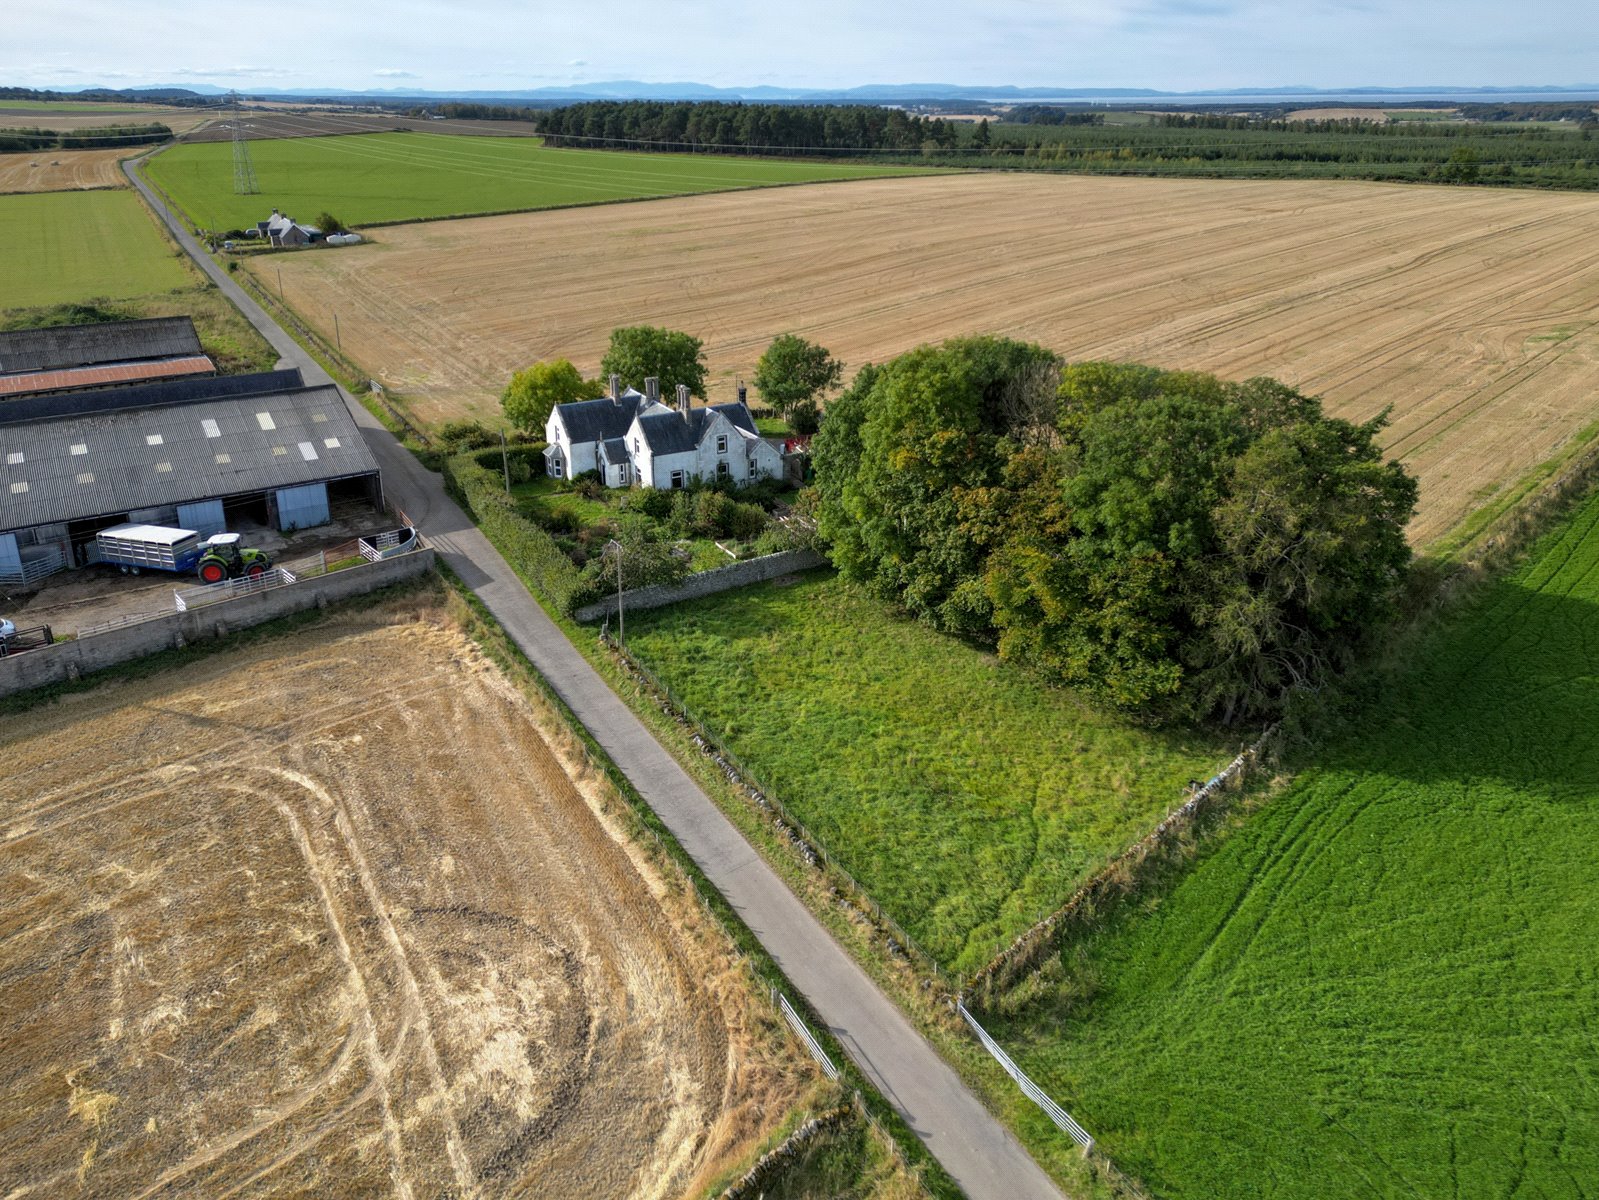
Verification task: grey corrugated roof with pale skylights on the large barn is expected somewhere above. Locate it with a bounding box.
[0,381,377,530]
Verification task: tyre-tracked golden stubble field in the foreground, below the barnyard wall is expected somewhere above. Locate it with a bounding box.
[0,597,807,1200]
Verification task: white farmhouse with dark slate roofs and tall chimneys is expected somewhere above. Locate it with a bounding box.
[544,376,784,490]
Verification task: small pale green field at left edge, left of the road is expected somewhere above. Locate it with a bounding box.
[0,190,193,309]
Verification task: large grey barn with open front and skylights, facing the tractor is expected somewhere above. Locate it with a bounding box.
[0,370,382,584]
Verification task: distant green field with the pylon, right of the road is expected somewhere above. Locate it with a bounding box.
[147,133,933,230]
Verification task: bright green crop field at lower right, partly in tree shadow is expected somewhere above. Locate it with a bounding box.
[991,498,1599,1200]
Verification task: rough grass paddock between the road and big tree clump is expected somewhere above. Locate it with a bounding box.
[627,573,1238,971]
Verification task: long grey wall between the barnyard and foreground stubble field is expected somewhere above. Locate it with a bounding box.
[0,549,433,696]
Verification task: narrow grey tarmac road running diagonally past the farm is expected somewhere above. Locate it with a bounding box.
[123,163,1060,1200]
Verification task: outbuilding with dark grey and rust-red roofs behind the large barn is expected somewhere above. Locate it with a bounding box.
[0,317,216,398]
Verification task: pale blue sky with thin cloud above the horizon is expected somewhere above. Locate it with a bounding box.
[0,0,1599,91]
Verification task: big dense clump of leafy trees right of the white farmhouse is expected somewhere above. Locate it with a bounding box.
[812,338,1417,722]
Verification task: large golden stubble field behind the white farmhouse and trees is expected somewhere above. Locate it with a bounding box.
[261,174,1599,542]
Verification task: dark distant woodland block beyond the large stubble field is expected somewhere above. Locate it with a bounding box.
[539,101,959,154]
